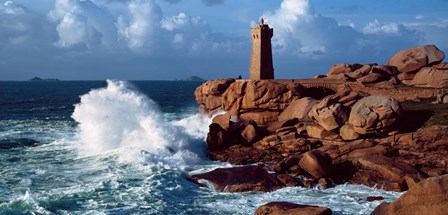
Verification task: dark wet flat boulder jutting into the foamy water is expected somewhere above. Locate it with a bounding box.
[191,166,279,192]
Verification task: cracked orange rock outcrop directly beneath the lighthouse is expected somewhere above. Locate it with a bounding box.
[195,79,303,126]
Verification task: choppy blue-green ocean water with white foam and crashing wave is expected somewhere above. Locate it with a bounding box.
[0,80,401,214]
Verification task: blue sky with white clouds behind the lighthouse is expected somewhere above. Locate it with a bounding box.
[0,0,448,80]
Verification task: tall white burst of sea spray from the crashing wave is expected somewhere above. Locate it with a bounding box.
[72,80,205,165]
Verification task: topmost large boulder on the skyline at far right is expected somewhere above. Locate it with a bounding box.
[387,45,445,72]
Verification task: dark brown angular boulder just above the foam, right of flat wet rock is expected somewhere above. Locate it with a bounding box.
[299,149,332,179]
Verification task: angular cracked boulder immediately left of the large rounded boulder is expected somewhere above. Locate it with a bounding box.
[308,98,349,131]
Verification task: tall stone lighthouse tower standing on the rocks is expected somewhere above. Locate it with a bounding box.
[249,18,274,80]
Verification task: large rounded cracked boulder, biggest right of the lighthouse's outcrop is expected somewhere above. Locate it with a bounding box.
[348,96,401,134]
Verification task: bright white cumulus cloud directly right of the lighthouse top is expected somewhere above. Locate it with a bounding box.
[264,0,359,56]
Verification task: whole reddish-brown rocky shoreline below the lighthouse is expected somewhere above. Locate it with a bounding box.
[191,45,448,214]
